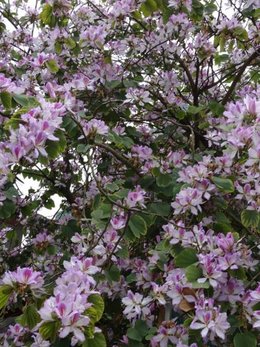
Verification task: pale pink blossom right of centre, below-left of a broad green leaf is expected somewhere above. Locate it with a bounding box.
[171,188,203,215]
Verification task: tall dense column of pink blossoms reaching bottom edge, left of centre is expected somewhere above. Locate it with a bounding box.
[39,257,99,346]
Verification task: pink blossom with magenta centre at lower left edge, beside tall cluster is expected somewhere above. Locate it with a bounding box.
[2,267,44,290]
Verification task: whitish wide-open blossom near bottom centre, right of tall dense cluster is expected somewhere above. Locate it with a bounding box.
[122,290,152,320]
